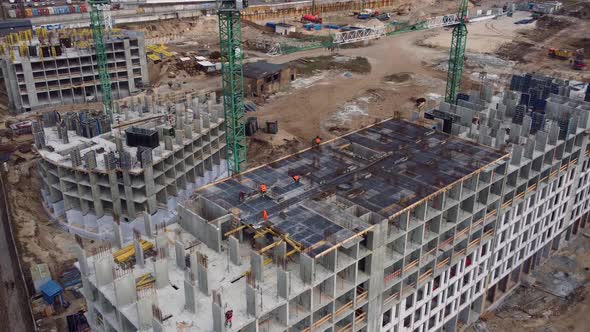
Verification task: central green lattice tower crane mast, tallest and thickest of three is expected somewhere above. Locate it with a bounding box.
[217,0,248,174]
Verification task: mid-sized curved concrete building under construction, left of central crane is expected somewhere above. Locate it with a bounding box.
[33,93,227,242]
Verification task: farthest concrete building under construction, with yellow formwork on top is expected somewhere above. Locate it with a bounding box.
[0,29,149,113]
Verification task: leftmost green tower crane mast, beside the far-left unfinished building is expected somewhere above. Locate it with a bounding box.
[89,0,113,122]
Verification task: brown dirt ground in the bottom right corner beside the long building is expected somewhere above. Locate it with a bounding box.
[467,229,590,332]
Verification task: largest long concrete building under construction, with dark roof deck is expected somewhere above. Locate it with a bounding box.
[78,76,590,332]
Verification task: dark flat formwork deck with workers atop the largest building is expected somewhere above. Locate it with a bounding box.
[197,120,507,256]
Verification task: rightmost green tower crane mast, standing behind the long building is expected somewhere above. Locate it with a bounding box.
[445,0,468,104]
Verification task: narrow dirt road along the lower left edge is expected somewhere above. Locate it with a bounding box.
[0,172,34,331]
